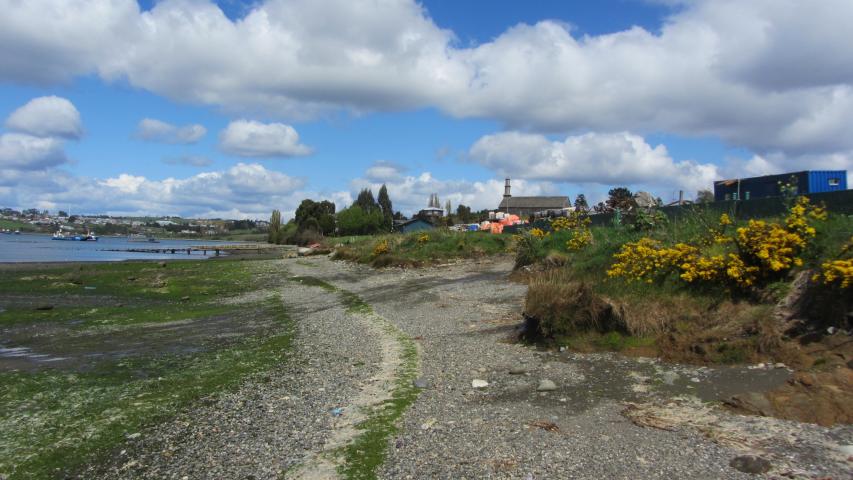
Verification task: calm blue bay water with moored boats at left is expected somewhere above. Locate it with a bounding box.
[0,234,250,263]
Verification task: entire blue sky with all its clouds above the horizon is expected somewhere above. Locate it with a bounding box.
[0,0,853,219]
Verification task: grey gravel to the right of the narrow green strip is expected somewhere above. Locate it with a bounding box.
[289,259,853,479]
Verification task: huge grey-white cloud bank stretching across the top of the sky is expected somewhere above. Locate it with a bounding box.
[0,0,853,163]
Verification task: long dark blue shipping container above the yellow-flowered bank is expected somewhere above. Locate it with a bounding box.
[714,170,847,202]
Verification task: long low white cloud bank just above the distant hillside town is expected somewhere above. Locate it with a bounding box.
[0,163,316,218]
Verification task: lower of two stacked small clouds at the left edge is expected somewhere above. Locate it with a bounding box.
[0,133,67,170]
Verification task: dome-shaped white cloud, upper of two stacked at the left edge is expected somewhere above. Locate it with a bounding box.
[6,96,83,139]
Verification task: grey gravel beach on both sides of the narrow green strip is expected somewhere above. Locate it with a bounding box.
[84,257,853,479]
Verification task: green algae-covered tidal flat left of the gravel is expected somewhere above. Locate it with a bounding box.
[0,259,292,479]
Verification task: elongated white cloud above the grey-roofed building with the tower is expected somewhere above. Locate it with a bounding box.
[469,132,719,195]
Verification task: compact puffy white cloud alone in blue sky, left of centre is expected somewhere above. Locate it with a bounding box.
[219,120,311,157]
